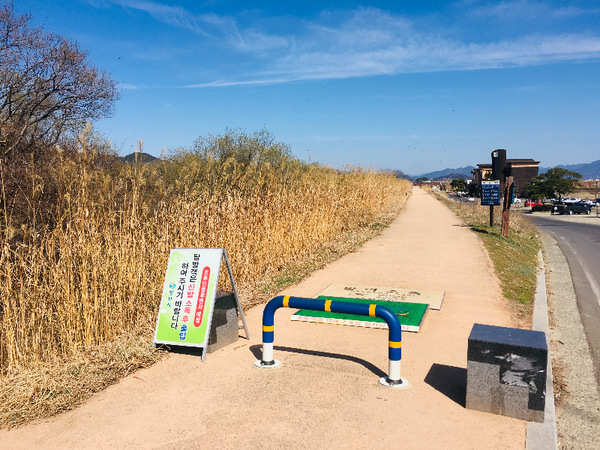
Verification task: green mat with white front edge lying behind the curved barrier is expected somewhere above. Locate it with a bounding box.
[290,296,427,332]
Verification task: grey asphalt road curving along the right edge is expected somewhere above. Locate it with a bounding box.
[532,211,600,385]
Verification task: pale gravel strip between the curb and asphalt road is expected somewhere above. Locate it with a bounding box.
[541,233,600,449]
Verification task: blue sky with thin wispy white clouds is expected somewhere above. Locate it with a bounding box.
[14,0,600,175]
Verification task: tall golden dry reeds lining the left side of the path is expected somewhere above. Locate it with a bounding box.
[0,130,411,427]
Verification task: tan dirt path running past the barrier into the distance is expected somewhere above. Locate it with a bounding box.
[0,189,527,450]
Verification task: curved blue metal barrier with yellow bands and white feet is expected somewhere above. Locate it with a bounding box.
[254,296,409,388]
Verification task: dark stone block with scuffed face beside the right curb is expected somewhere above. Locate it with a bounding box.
[466,324,548,422]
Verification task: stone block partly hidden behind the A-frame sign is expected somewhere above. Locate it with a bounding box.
[207,291,239,353]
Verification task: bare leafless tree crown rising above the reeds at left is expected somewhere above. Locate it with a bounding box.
[0,3,119,159]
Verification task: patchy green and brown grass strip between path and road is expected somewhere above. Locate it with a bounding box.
[428,190,540,323]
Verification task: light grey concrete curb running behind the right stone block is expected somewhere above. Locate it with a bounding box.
[525,250,558,450]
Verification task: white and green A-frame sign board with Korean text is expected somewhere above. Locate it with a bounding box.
[154,248,250,361]
